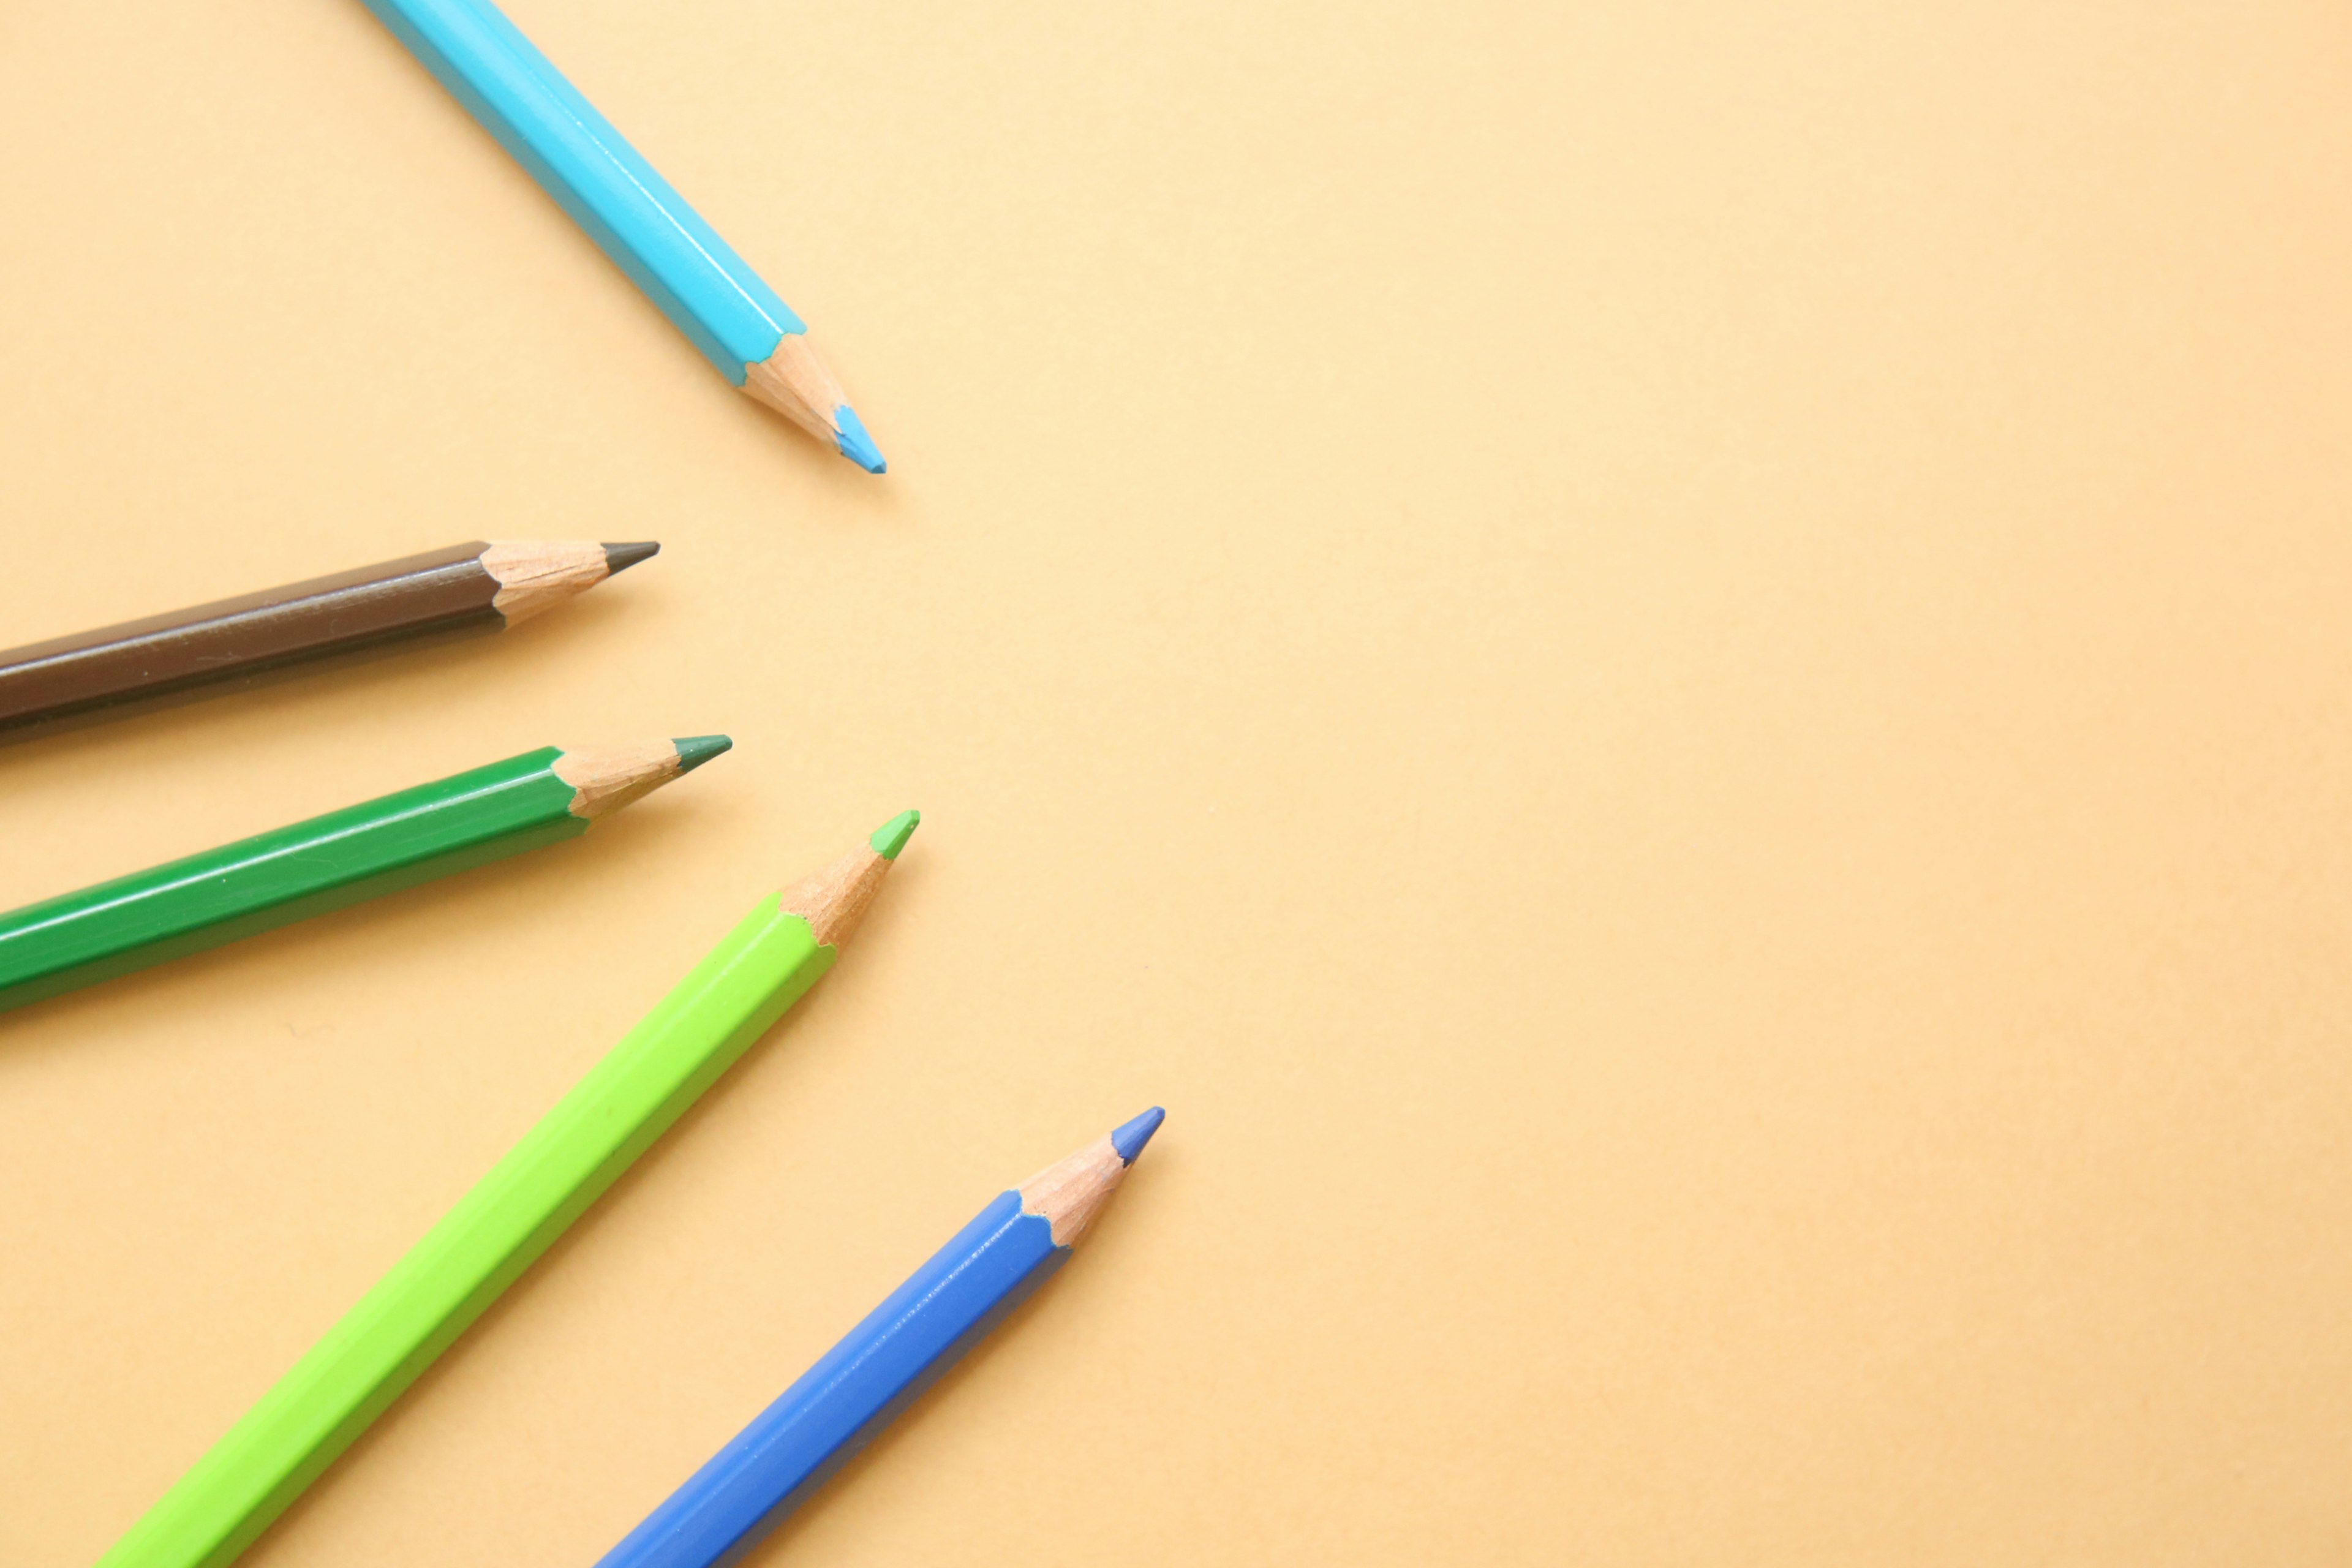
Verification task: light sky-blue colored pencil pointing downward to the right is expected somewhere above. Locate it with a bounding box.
[364,0,882,472]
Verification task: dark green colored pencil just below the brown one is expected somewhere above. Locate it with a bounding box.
[0,736,731,1011]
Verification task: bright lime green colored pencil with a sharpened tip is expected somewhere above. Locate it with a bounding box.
[99,811,919,1568]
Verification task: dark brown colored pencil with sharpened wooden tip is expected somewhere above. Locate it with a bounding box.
[0,538,661,741]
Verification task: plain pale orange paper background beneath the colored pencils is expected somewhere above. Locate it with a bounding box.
[0,0,2352,1568]
